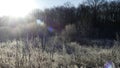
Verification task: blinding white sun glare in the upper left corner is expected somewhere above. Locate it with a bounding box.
[0,0,37,17]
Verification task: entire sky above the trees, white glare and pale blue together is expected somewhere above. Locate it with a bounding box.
[0,0,83,17]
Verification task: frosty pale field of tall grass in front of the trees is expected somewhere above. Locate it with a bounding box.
[0,40,120,68]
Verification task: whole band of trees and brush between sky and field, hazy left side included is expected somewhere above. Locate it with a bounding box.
[0,0,120,41]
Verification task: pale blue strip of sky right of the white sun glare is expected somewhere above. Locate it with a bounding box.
[36,0,85,9]
